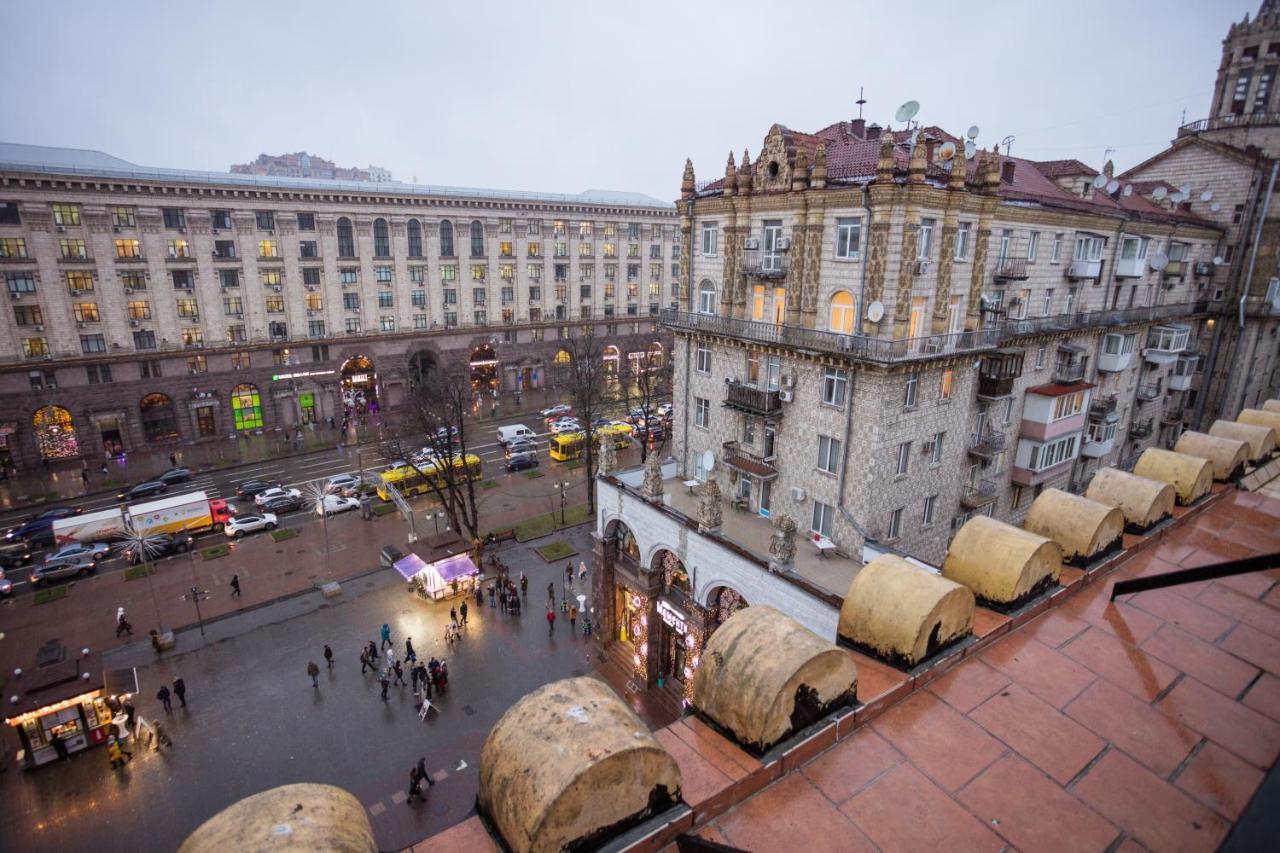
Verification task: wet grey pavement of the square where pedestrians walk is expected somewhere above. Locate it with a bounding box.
[0,528,596,850]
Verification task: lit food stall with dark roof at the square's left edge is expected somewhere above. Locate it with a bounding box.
[5,642,138,768]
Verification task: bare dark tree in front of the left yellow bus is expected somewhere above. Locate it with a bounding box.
[383,369,481,556]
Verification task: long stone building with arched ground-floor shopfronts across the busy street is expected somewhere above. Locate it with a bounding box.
[0,145,680,470]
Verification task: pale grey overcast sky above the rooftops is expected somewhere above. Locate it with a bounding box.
[0,0,1258,199]
